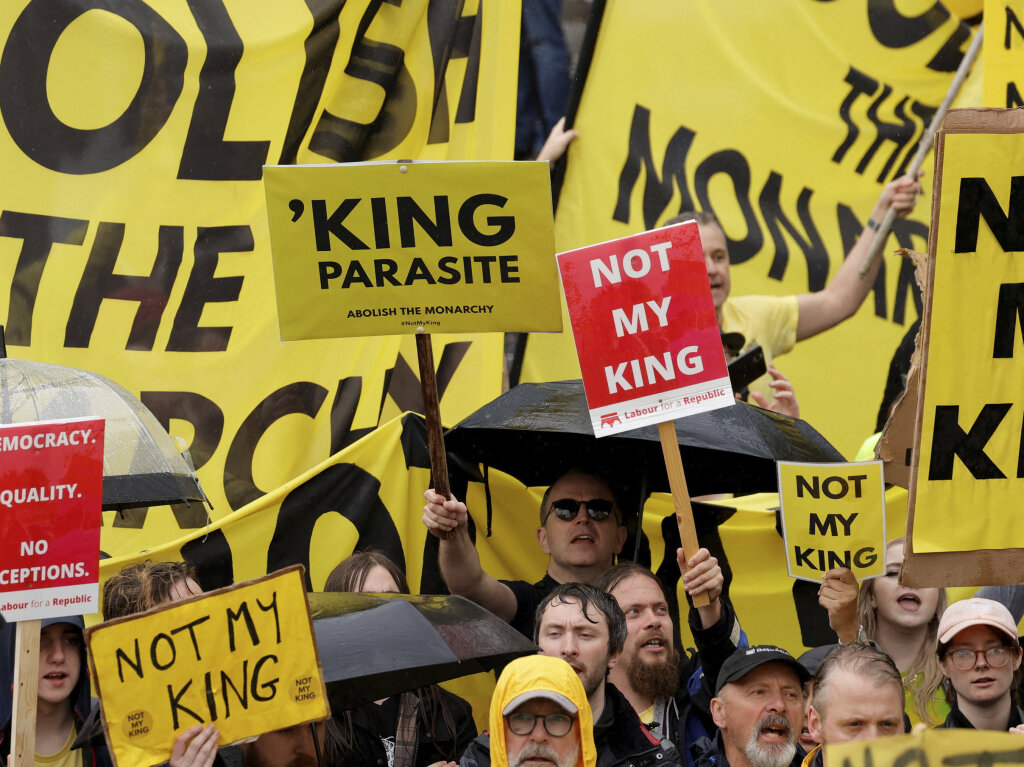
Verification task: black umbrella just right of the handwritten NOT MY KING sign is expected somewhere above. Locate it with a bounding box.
[309,593,538,714]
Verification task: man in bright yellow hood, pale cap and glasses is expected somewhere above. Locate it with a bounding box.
[459,655,597,767]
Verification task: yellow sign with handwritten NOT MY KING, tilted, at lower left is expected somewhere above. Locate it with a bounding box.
[86,565,331,767]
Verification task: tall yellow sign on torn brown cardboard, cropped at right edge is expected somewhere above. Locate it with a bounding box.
[903,110,1024,586]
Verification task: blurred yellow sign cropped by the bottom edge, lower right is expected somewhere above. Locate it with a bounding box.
[825,728,1024,767]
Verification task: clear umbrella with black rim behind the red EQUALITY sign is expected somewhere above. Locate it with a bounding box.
[0,357,206,509]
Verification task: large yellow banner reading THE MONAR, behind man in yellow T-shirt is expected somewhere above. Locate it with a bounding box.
[523,0,972,456]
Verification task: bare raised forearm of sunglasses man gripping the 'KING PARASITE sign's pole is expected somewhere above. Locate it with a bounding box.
[423,489,518,621]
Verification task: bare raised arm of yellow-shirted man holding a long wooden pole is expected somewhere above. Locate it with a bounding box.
[797,176,921,341]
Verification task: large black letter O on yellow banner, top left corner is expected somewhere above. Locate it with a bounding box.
[0,0,188,174]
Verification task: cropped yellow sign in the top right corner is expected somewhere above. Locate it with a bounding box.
[981,0,1024,106]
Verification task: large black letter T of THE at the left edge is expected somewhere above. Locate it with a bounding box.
[0,210,89,346]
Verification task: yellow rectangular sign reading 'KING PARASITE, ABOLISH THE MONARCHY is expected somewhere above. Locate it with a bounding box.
[263,162,562,340]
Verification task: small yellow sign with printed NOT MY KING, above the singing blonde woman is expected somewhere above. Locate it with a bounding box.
[776,461,886,582]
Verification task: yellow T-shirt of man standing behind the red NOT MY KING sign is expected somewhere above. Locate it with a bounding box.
[718,296,800,398]
